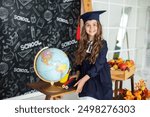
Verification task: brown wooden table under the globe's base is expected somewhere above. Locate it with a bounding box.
[27,80,75,100]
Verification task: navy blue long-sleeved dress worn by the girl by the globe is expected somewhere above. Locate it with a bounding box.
[76,40,113,100]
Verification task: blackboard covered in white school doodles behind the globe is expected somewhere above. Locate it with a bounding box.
[0,0,80,99]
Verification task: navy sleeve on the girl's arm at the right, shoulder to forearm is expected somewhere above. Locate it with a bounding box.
[87,41,108,78]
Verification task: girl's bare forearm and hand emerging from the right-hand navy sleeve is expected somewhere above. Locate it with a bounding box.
[74,75,90,93]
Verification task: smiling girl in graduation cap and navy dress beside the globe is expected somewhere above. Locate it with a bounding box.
[71,11,113,100]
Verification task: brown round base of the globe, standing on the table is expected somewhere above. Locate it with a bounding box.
[45,82,63,93]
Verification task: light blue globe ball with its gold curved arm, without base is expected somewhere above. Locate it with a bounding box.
[34,47,70,83]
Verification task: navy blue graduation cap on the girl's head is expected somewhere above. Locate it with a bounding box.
[80,10,106,23]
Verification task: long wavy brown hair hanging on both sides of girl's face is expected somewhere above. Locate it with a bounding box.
[75,21,102,65]
